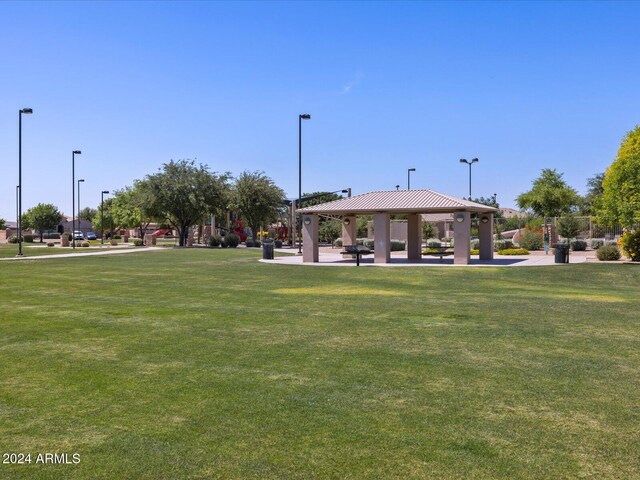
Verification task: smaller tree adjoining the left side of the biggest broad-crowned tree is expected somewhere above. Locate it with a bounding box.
[111,181,161,238]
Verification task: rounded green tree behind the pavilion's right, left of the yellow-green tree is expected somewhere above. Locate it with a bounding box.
[516,168,581,217]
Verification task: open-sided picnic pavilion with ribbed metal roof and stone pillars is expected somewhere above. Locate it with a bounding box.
[298,190,498,265]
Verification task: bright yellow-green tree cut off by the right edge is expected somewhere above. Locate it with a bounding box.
[598,125,640,228]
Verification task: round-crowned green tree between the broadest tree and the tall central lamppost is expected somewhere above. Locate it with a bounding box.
[233,171,284,240]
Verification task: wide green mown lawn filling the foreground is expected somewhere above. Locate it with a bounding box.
[0,249,640,480]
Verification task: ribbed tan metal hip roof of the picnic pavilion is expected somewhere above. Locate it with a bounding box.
[298,190,497,214]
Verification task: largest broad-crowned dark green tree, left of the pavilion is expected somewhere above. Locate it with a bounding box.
[140,160,229,247]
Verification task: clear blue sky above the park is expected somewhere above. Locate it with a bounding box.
[0,2,640,220]
